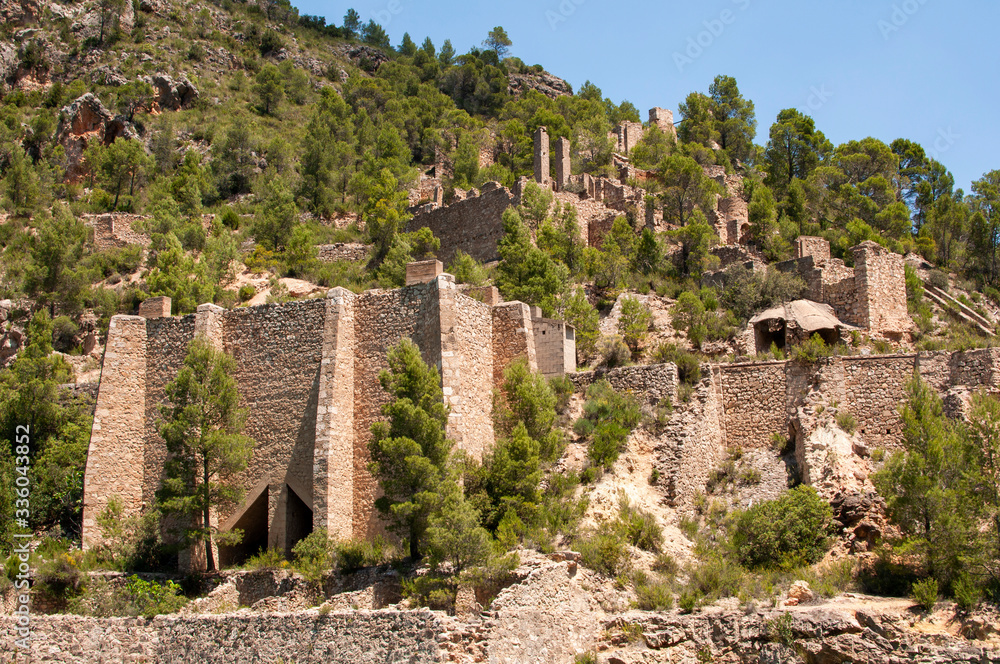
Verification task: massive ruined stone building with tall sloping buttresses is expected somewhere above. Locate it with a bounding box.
[83,261,576,564]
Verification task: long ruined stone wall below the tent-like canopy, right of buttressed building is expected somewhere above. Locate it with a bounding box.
[570,348,1000,506]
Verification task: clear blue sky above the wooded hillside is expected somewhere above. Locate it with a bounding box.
[293,0,1000,192]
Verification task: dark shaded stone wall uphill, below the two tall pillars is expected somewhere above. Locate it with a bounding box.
[407,183,518,265]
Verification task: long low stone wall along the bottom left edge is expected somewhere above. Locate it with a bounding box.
[0,610,447,664]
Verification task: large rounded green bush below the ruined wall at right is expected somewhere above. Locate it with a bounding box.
[730,486,833,569]
